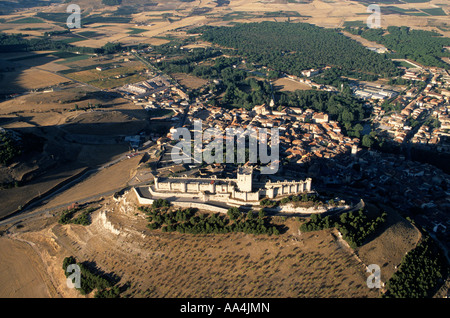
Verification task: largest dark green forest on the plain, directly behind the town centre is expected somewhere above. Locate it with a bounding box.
[198,22,399,77]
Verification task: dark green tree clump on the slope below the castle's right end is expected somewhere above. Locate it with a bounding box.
[300,209,387,248]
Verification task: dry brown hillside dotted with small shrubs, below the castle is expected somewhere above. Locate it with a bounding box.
[0,193,420,297]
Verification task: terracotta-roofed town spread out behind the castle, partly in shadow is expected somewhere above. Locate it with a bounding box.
[96,46,450,248]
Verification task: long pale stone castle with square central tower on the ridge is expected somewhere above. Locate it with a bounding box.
[148,167,312,205]
